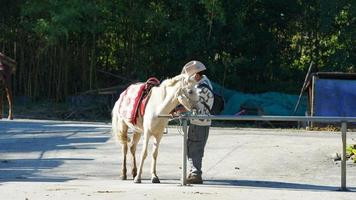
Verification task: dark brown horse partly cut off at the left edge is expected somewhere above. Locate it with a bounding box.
[0,52,16,120]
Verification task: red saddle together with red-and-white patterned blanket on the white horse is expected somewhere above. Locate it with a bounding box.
[119,77,160,124]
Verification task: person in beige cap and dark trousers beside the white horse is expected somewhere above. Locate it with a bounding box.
[182,61,214,184]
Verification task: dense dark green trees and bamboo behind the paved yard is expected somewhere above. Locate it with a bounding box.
[0,0,356,102]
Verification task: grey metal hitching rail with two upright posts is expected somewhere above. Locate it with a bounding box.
[159,115,356,191]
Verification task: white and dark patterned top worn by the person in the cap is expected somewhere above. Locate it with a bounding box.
[190,75,214,126]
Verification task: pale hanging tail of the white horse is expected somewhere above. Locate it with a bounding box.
[111,101,130,144]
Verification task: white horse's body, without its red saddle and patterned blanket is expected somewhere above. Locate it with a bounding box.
[112,74,198,183]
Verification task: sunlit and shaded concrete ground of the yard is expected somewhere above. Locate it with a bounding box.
[0,119,356,200]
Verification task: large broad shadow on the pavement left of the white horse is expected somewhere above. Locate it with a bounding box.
[0,120,110,182]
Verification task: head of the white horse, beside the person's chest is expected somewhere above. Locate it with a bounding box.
[176,74,199,111]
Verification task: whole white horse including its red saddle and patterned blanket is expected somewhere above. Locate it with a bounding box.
[112,74,198,183]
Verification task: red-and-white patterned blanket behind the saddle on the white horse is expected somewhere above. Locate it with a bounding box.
[119,83,145,124]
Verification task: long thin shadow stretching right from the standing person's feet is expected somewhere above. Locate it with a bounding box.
[204,180,356,192]
